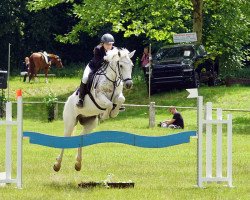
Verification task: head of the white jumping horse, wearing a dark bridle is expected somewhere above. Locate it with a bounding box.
[106,48,135,89]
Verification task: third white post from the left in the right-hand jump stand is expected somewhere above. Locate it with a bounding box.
[216,108,223,178]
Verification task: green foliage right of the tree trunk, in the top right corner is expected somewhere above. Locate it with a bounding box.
[203,0,250,75]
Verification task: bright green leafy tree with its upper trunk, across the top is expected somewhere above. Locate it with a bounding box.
[28,0,250,74]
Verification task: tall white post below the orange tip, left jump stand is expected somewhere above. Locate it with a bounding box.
[17,96,23,189]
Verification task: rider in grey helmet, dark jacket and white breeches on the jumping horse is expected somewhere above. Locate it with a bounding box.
[76,33,115,108]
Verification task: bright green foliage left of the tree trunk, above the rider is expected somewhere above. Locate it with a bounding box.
[28,0,192,43]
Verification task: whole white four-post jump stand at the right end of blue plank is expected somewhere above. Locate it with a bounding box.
[197,96,233,187]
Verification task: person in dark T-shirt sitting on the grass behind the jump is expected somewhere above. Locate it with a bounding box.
[159,106,184,129]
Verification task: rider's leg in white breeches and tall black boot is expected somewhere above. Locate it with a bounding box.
[76,65,91,108]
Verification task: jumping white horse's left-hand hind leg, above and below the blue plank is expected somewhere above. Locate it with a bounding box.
[53,117,76,172]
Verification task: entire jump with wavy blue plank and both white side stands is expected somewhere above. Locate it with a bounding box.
[0,90,232,188]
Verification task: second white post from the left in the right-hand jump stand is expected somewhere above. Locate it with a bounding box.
[206,102,212,178]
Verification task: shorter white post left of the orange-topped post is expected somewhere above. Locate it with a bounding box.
[5,101,13,180]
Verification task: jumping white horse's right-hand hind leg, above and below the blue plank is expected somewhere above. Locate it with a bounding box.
[75,116,98,171]
